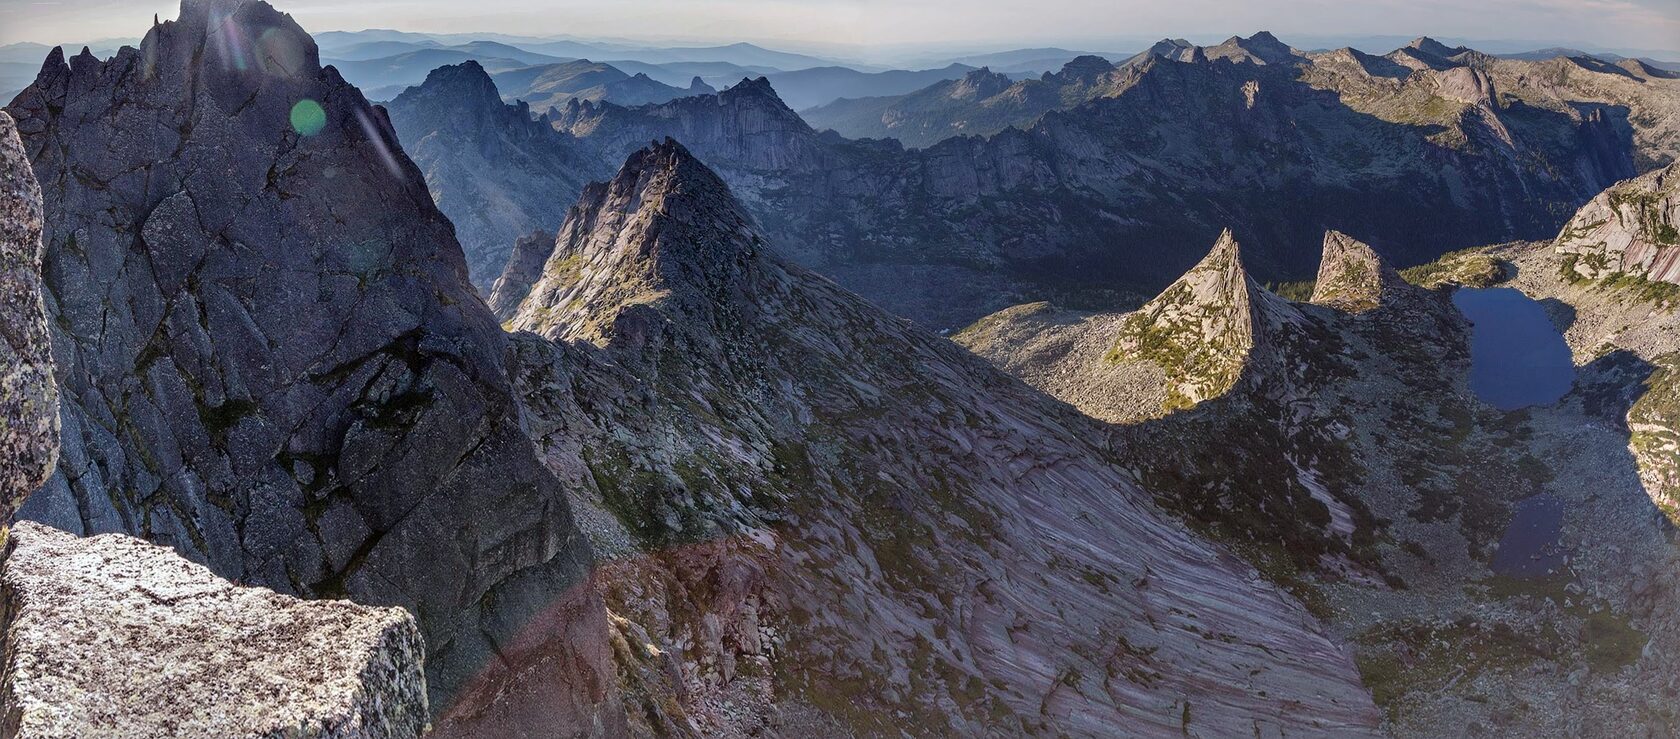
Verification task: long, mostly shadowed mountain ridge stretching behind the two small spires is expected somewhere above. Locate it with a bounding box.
[400,36,1653,329]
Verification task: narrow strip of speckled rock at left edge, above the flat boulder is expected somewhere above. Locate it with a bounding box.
[0,113,59,521]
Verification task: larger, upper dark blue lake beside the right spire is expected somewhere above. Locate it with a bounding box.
[1453,287,1574,410]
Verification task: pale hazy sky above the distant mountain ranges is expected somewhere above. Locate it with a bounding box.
[0,0,1680,54]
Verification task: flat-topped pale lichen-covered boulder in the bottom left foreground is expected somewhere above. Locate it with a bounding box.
[0,522,427,739]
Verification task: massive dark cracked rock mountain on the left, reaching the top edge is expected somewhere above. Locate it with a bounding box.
[10,0,617,732]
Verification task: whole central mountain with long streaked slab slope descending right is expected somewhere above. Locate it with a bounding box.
[497,141,1376,736]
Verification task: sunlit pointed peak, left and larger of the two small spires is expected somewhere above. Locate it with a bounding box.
[1107,228,1295,410]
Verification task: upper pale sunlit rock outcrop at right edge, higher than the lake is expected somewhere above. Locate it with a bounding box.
[1554,165,1680,282]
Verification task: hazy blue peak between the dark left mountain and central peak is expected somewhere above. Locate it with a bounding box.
[386,62,594,296]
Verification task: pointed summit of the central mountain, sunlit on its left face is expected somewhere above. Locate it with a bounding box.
[511,138,763,341]
